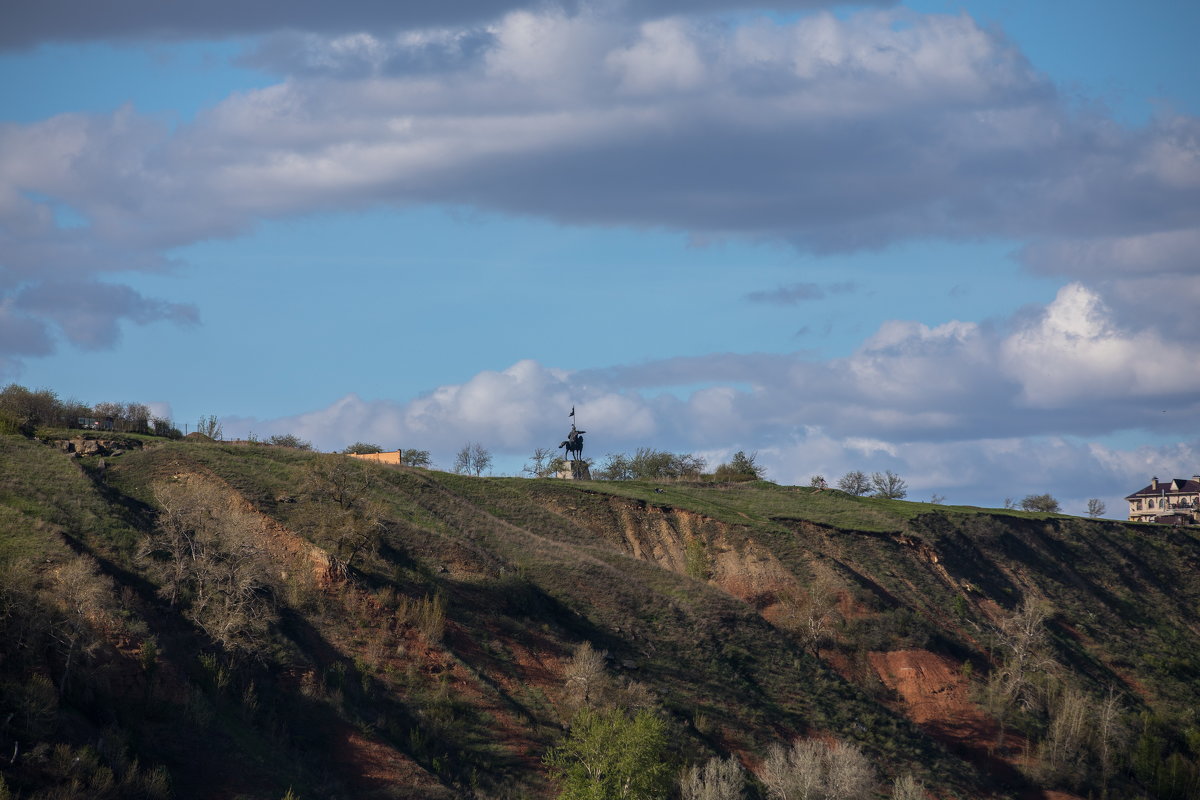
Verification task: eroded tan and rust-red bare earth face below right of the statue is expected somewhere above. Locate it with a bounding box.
[530,495,1056,798]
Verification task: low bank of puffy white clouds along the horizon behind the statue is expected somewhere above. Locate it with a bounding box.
[226,278,1200,512]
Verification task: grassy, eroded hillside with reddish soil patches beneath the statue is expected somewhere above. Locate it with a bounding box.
[0,434,1200,799]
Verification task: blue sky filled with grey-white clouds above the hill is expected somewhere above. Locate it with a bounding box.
[0,0,1200,517]
